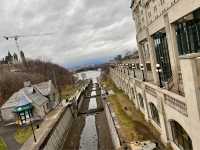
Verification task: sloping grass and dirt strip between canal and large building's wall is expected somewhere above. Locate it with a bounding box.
[103,77,166,150]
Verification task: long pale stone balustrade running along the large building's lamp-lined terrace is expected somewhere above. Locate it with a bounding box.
[112,67,188,117]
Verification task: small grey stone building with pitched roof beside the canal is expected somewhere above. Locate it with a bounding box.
[0,81,58,121]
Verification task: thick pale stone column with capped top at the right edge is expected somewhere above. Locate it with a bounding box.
[180,53,200,150]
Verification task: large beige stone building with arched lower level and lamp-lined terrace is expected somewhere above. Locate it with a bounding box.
[110,0,200,150]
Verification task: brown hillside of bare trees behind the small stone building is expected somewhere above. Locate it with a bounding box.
[0,60,73,104]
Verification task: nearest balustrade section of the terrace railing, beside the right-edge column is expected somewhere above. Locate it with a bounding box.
[165,95,188,116]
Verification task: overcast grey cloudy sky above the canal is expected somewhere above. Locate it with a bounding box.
[0,0,136,67]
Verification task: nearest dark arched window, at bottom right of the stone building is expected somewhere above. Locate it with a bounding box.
[170,120,193,150]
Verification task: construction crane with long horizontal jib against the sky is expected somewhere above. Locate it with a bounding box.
[3,33,55,65]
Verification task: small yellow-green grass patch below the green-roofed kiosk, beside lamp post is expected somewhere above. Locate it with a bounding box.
[14,127,32,144]
